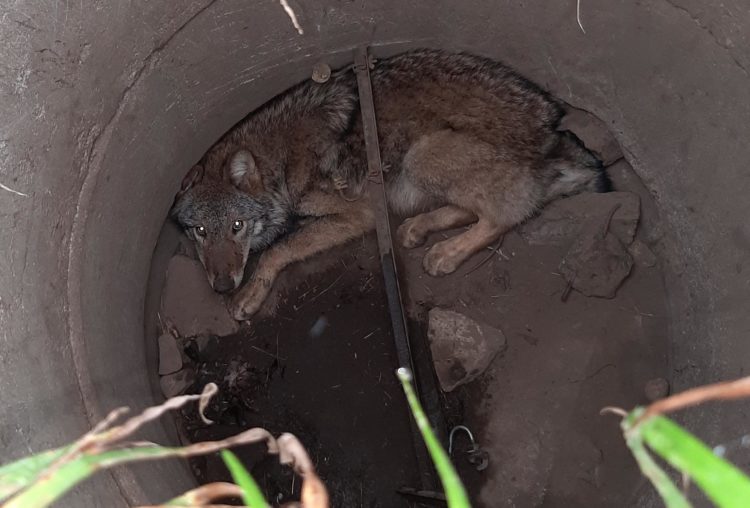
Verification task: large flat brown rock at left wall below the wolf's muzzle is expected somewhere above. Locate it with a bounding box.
[161,255,239,337]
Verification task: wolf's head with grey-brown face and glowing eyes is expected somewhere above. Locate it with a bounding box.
[172,150,290,293]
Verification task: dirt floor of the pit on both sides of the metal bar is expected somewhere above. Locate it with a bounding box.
[163,158,669,508]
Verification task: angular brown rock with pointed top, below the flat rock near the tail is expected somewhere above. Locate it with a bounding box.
[560,203,633,298]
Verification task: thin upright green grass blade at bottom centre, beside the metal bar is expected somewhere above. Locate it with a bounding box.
[396,368,471,508]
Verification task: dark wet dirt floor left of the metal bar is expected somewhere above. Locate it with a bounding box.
[175,237,419,508]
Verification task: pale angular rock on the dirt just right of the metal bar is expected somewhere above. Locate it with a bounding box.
[427,308,507,392]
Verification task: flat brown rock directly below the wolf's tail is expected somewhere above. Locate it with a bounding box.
[518,192,640,246]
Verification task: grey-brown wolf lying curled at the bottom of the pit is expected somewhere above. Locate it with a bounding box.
[172,49,609,321]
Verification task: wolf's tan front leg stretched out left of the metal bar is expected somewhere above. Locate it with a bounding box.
[230,193,374,321]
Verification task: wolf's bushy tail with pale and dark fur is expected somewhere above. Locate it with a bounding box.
[546,131,612,201]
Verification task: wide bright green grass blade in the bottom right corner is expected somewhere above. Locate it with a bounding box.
[637,416,750,508]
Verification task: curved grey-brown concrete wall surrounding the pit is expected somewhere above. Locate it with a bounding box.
[0,0,750,506]
